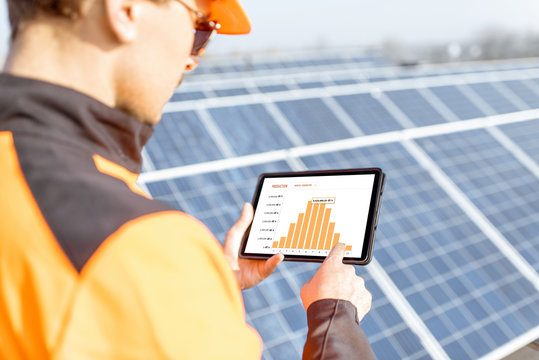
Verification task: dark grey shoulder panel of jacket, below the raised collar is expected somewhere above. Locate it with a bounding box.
[14,132,170,272]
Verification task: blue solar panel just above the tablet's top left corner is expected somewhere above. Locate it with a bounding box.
[209,104,292,155]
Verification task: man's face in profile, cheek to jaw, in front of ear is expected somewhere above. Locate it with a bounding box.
[116,0,209,124]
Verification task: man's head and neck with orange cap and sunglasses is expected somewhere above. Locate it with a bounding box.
[6,0,250,123]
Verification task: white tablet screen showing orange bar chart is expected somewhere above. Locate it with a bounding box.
[247,176,373,257]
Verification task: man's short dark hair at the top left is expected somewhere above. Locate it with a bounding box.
[7,0,85,39]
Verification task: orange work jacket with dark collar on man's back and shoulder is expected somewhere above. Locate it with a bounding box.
[0,74,262,360]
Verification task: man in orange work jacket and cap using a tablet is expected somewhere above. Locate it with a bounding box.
[0,0,372,359]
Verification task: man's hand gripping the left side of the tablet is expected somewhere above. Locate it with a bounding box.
[223,203,284,289]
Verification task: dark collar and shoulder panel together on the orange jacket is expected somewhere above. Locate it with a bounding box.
[0,74,170,271]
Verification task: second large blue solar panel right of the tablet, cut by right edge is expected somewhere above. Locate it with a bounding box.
[418,130,539,270]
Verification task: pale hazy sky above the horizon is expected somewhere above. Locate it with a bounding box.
[0,0,539,55]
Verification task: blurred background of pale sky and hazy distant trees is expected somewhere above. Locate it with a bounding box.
[0,0,539,62]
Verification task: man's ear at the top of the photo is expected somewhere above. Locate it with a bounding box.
[103,0,139,43]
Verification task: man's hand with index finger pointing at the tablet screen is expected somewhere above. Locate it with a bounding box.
[300,243,372,321]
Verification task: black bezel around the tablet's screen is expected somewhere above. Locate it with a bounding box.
[239,168,385,265]
